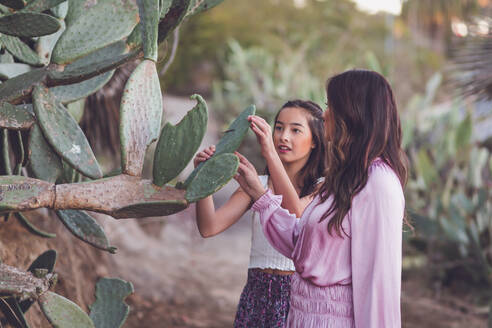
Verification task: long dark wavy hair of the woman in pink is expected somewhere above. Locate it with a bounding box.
[319,70,408,236]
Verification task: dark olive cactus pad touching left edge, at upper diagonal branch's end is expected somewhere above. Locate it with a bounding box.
[0,67,48,104]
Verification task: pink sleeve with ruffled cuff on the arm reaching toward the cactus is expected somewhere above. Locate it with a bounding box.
[252,189,297,258]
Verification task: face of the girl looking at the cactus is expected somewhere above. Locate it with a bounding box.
[273,107,315,165]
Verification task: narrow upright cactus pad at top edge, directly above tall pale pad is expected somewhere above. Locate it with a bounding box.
[137,0,160,61]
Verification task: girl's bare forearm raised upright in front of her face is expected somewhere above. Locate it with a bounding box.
[248,115,305,217]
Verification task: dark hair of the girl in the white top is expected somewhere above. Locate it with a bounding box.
[265,99,326,197]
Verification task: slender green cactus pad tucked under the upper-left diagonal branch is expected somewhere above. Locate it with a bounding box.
[50,71,114,104]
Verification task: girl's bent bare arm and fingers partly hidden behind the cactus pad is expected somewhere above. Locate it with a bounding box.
[194,146,251,238]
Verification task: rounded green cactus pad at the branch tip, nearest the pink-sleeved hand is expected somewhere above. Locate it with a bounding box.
[185,153,239,203]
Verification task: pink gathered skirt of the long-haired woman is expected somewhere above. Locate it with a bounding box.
[286,273,355,328]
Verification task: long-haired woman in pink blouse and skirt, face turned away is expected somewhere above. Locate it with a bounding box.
[236,70,407,328]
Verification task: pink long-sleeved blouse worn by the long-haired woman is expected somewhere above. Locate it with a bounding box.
[253,159,405,328]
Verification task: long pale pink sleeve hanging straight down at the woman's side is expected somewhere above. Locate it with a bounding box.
[350,166,405,328]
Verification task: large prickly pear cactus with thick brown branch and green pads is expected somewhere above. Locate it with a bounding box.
[0,0,242,328]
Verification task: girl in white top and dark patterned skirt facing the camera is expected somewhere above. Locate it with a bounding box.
[194,100,326,327]
